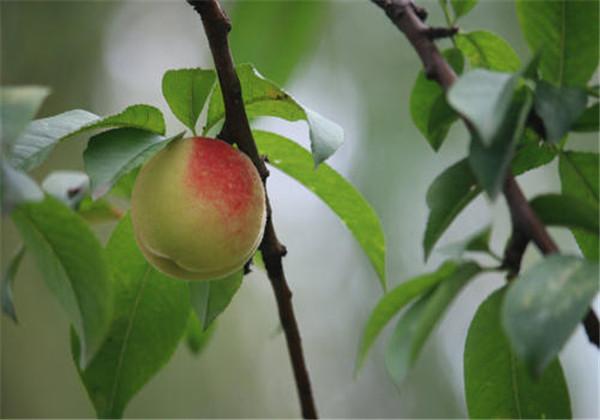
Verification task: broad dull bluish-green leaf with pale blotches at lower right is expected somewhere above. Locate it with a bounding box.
[502,254,600,376]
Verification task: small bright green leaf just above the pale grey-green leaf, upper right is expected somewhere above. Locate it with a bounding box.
[454,31,521,73]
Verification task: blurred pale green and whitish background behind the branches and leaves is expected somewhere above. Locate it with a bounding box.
[0,0,600,418]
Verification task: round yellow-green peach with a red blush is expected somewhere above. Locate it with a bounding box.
[131,137,266,280]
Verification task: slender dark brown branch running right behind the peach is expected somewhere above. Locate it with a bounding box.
[187,0,317,419]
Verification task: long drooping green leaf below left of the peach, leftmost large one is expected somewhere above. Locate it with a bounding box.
[12,197,112,365]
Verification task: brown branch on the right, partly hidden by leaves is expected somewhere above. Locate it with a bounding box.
[371,0,600,347]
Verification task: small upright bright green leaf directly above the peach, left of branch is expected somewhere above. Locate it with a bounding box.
[162,69,216,134]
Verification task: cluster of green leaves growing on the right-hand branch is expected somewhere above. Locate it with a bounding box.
[357,0,599,418]
